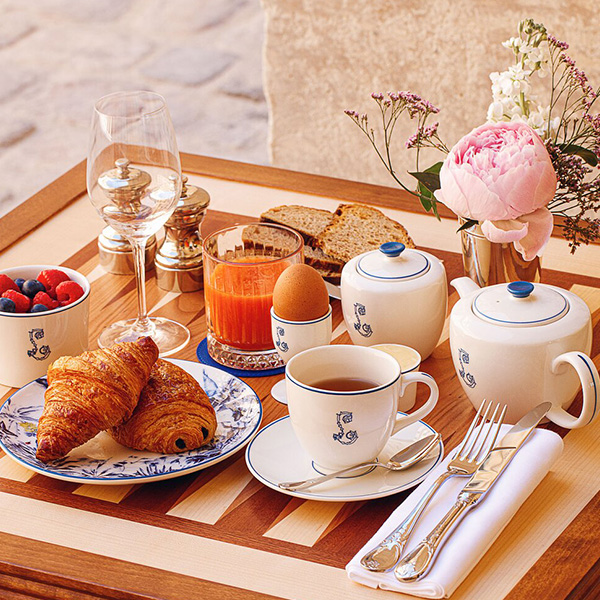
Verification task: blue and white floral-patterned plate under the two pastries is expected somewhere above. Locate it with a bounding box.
[0,359,262,485]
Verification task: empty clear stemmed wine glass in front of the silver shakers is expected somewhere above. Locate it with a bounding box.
[87,91,190,356]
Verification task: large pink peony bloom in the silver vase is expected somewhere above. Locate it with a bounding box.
[435,121,557,260]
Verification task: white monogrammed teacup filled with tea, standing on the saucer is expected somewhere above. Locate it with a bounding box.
[285,344,439,472]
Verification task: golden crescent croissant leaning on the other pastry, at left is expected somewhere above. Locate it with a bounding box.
[36,337,158,462]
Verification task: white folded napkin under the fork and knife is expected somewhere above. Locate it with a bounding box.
[346,425,563,598]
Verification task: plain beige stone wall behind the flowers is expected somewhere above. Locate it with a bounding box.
[262,0,600,186]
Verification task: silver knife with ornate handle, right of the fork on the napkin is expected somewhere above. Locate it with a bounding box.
[394,402,552,581]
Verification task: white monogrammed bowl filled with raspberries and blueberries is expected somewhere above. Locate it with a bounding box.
[0,265,90,387]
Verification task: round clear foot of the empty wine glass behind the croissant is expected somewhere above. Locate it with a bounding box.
[98,317,190,357]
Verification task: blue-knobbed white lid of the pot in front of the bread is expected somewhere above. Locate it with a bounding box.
[356,242,431,281]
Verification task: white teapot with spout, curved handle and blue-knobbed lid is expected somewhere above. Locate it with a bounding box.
[450,277,600,429]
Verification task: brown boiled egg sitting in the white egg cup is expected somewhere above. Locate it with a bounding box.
[273,264,329,321]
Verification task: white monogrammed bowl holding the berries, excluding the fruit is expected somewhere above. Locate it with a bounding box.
[0,265,90,387]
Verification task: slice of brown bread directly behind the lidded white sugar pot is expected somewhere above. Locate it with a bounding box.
[315,204,415,262]
